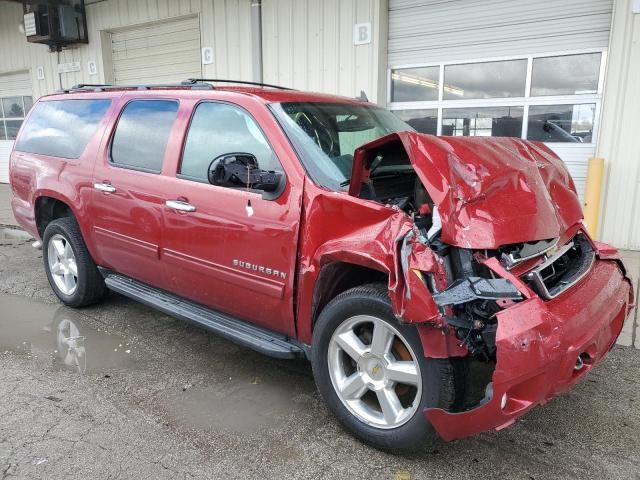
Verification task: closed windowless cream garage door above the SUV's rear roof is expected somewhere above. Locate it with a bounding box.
[111,17,202,85]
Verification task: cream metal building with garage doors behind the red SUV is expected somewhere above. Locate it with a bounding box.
[0,0,640,249]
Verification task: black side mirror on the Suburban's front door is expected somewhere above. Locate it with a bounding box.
[208,153,282,192]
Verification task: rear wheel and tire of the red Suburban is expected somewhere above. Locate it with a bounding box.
[42,217,107,308]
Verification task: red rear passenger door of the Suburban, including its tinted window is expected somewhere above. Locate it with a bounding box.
[91,94,179,288]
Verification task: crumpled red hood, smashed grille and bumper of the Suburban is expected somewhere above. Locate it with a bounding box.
[349,132,633,440]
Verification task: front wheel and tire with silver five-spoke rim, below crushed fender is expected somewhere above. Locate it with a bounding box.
[311,284,466,452]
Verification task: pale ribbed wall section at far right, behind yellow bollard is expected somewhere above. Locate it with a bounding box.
[598,0,640,250]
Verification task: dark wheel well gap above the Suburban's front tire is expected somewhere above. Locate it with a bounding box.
[312,262,389,324]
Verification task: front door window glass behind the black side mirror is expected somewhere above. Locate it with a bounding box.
[179,102,282,182]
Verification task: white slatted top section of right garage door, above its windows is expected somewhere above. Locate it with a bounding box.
[388,0,613,66]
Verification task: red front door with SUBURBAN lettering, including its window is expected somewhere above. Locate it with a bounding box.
[161,101,301,335]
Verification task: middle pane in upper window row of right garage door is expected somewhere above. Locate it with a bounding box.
[443,59,527,100]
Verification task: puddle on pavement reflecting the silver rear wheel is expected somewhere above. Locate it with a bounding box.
[0,294,134,374]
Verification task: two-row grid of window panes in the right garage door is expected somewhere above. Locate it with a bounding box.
[389,51,605,143]
